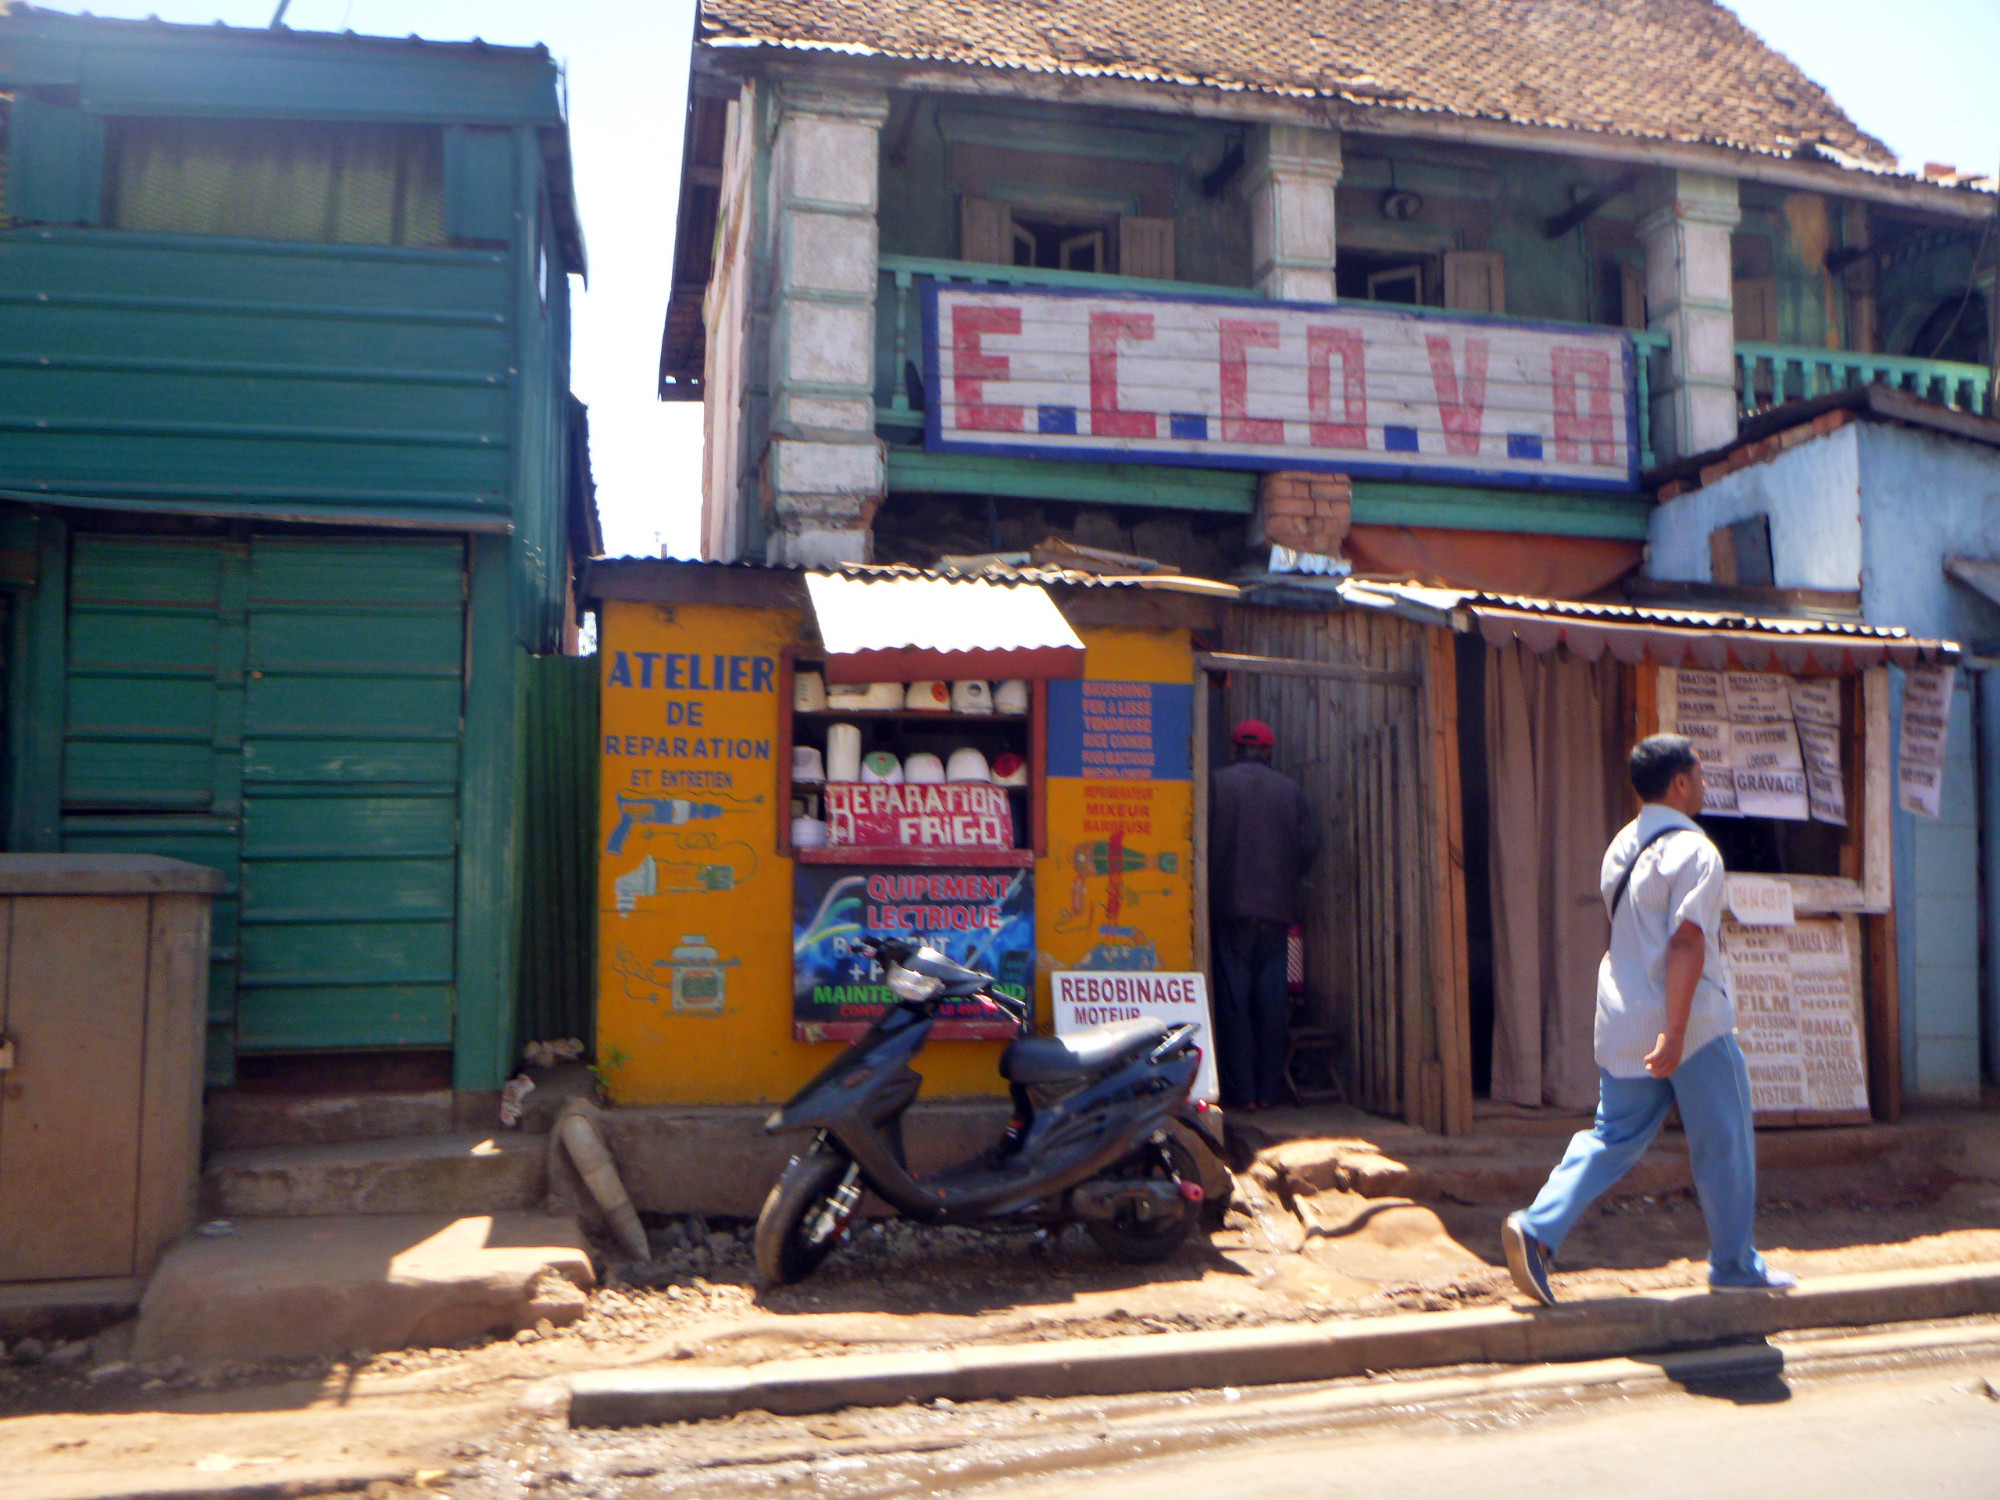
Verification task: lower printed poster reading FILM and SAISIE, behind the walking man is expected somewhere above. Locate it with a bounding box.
[1722,916,1868,1116]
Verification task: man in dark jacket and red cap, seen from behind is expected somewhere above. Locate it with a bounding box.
[1208,718,1320,1110]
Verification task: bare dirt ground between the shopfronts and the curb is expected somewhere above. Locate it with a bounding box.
[0,1114,2000,1500]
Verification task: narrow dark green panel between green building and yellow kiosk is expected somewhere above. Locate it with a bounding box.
[514,656,598,1046]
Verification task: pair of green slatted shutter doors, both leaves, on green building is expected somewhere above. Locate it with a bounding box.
[62,534,466,1082]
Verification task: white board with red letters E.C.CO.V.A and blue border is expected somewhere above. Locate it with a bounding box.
[924,282,1638,490]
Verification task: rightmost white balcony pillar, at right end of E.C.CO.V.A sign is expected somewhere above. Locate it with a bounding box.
[1638,172,1742,462]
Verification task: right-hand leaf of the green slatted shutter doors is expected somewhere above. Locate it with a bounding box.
[236,538,466,1050]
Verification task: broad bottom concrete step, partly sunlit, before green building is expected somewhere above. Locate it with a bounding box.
[130,1214,596,1362]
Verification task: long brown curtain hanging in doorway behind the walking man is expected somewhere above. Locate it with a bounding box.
[1486,644,1630,1110]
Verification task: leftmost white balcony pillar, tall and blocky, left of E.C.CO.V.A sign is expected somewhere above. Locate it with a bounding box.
[762,84,888,566]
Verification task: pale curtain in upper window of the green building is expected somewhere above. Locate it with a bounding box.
[106,118,444,248]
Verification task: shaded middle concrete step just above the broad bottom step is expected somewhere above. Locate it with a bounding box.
[202,1130,550,1220]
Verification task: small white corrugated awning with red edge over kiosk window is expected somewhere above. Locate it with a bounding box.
[806,572,1084,682]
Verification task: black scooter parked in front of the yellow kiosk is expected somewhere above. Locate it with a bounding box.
[756,940,1222,1284]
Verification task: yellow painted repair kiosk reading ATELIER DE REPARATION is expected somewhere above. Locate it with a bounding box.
[588,560,1236,1104]
